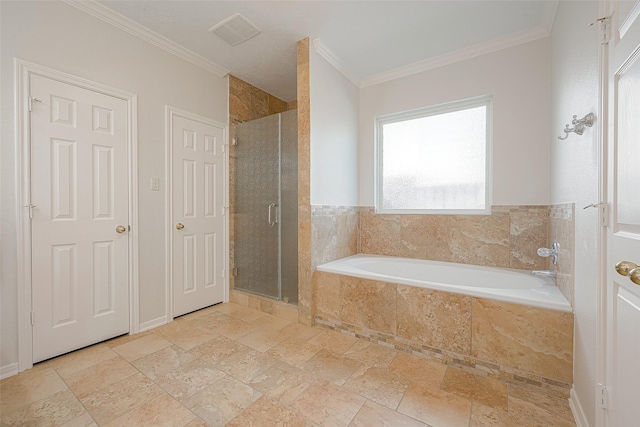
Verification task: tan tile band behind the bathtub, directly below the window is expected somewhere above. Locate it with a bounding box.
[360,206,549,270]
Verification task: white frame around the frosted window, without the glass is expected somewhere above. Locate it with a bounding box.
[374,95,493,215]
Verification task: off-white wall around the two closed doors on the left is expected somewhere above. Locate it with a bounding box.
[0,1,228,367]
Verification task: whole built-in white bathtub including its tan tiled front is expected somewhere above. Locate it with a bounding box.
[313,254,573,397]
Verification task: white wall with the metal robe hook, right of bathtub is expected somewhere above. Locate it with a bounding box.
[550,1,599,426]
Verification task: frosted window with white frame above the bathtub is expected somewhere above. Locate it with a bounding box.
[376,96,491,214]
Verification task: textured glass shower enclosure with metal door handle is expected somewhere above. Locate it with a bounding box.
[233,110,298,304]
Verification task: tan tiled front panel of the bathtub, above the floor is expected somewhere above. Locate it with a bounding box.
[314,271,573,397]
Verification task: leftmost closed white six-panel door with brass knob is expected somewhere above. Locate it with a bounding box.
[30,74,129,362]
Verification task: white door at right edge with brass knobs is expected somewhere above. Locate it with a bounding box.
[605,1,640,427]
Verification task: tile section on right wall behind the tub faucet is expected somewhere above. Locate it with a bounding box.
[547,203,575,306]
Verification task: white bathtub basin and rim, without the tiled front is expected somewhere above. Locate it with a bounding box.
[317,254,572,312]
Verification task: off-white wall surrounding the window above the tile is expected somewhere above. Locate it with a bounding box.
[359,38,550,206]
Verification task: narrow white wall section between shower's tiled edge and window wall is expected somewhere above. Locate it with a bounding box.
[309,43,359,206]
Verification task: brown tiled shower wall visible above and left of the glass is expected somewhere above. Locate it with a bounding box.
[229,75,296,289]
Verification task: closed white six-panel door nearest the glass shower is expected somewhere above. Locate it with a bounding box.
[171,114,226,317]
